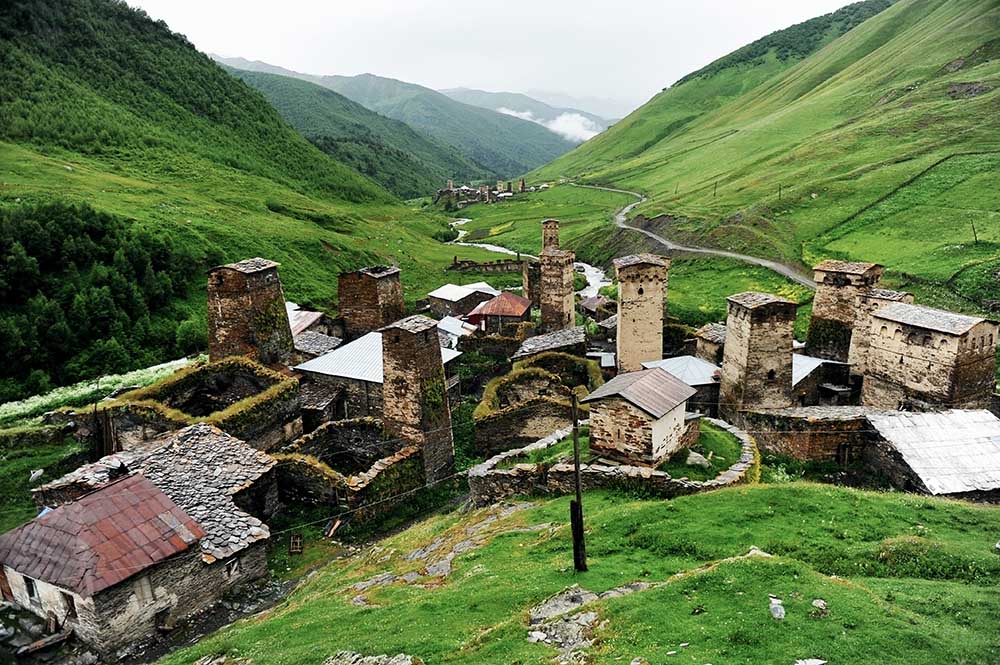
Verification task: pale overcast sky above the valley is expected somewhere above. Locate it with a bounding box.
[128,0,847,116]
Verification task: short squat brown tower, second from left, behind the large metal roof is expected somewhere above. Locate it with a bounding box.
[337,266,405,341]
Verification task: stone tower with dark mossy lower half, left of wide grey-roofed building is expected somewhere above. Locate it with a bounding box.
[806,259,884,362]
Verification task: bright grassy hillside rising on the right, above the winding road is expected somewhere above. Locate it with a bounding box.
[536,0,1000,310]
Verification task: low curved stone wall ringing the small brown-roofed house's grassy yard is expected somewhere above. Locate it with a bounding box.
[469,420,760,506]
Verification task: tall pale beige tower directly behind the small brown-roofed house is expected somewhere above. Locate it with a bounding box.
[614,254,670,372]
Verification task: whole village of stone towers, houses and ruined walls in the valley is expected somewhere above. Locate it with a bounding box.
[0,219,1000,653]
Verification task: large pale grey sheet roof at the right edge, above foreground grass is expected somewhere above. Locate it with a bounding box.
[868,410,1000,494]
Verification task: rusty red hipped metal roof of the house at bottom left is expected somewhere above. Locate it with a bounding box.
[0,475,205,597]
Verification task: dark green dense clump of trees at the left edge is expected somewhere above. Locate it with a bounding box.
[0,203,203,401]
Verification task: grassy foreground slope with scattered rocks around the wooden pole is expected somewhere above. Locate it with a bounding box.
[156,483,1000,665]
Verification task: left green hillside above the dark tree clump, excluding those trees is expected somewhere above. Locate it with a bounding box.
[0,0,516,316]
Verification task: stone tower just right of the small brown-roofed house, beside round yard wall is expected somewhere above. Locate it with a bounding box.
[719,291,796,423]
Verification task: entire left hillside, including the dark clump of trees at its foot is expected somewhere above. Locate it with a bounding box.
[0,0,524,401]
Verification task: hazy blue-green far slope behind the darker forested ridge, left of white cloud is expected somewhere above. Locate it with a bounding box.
[315,74,573,178]
